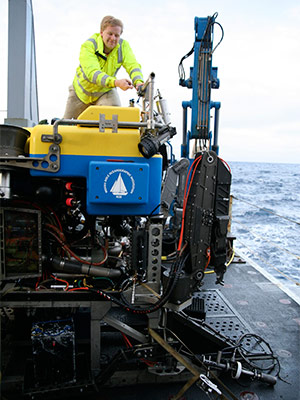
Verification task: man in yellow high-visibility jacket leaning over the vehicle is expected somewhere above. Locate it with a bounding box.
[64,15,144,119]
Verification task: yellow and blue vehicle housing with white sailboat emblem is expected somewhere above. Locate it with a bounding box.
[29,106,162,215]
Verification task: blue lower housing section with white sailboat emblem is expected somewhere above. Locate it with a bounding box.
[30,154,162,215]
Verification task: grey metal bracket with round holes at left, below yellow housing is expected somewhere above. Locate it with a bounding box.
[0,144,60,172]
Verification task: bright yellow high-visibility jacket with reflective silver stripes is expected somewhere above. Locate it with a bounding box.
[73,33,143,104]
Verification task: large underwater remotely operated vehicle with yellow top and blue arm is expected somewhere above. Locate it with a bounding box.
[0,14,276,399]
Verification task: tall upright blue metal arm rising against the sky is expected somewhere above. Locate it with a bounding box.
[179,14,221,157]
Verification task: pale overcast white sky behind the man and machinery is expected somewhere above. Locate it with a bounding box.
[0,0,300,163]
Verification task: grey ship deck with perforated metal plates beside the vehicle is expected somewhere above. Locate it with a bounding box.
[93,257,300,400]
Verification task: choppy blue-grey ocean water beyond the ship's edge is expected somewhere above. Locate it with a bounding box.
[229,162,300,296]
